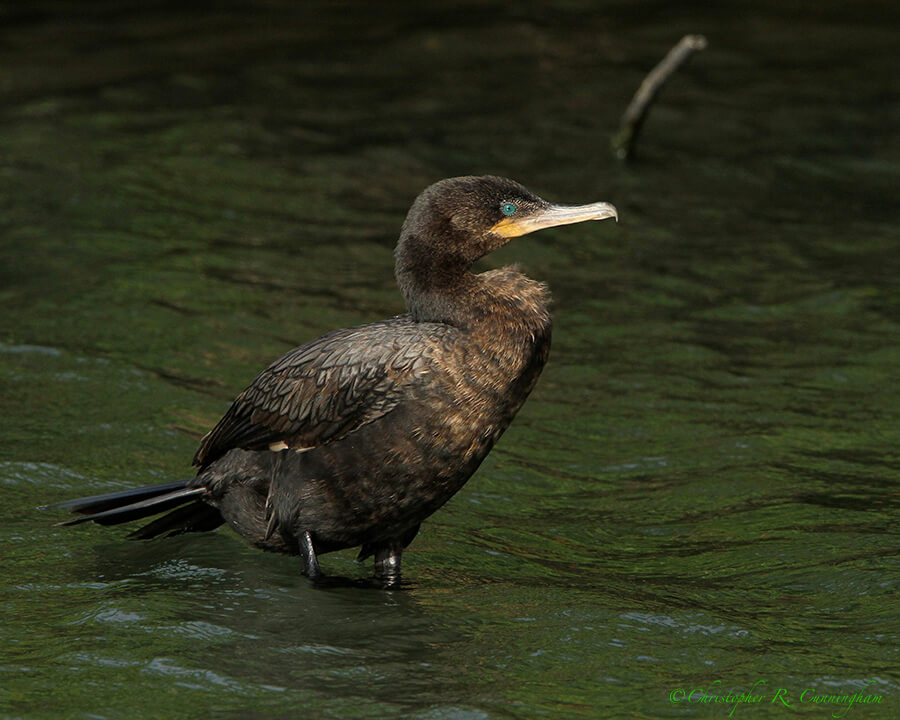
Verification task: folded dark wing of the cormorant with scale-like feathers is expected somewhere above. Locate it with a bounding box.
[194,315,458,468]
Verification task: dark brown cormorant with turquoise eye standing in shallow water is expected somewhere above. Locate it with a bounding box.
[45,176,617,584]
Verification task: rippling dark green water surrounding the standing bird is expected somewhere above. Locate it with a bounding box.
[0,0,900,720]
